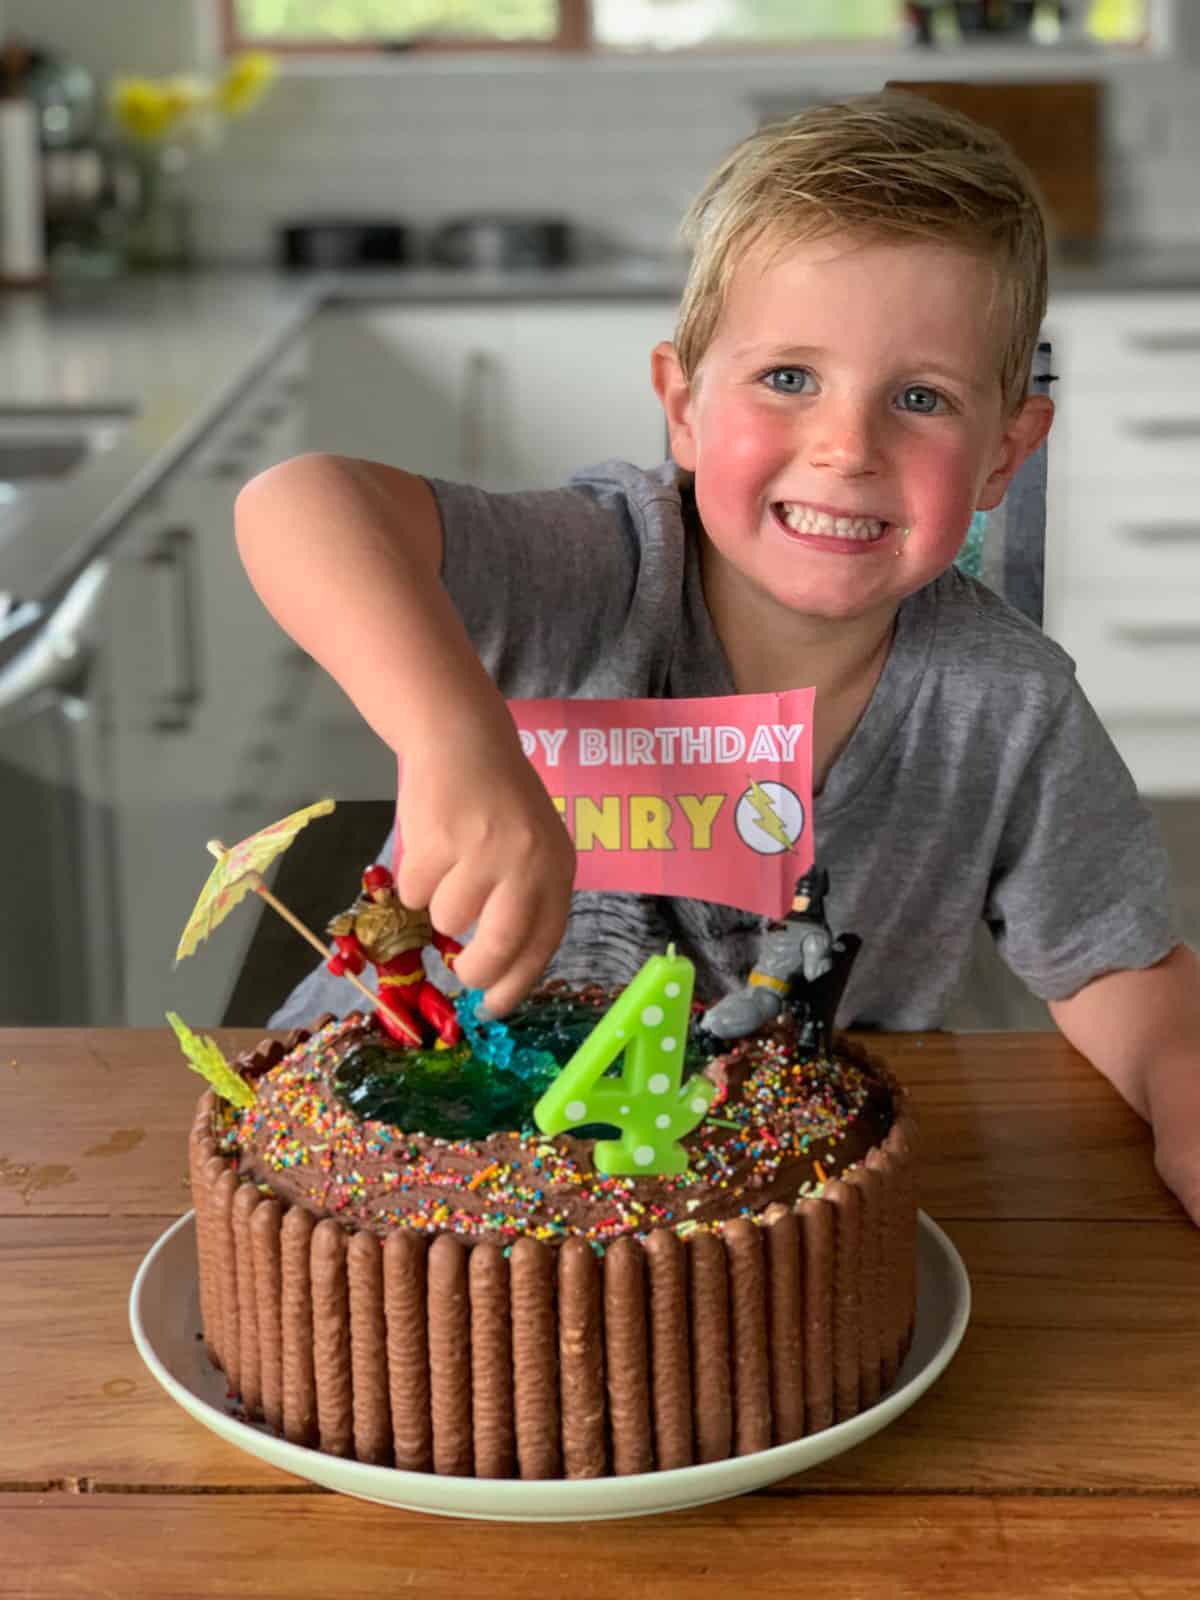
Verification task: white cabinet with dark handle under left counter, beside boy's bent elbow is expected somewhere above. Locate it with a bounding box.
[106,339,387,1027]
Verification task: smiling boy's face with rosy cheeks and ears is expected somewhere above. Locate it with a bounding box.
[654,235,1053,621]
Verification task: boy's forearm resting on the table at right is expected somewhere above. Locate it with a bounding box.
[1050,944,1200,1222]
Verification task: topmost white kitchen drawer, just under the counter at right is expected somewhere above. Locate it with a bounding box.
[1045,293,1200,392]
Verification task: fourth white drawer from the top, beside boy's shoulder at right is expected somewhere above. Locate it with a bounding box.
[1046,581,1200,723]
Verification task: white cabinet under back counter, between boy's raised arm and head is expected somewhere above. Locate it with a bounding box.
[302,299,675,491]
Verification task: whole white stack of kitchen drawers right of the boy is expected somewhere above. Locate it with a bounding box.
[1046,291,1200,795]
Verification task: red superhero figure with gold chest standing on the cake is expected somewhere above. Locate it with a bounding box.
[326,867,462,1048]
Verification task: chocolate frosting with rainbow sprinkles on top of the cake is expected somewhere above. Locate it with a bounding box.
[224,1014,893,1246]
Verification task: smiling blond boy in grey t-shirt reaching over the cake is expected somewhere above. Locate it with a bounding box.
[237,94,1200,1221]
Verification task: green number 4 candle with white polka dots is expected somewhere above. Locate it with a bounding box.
[533,944,715,1176]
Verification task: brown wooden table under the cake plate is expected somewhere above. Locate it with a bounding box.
[0,1029,1200,1600]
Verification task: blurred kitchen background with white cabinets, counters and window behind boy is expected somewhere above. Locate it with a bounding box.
[0,0,1200,1027]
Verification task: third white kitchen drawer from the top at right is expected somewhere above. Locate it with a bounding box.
[1046,486,1200,586]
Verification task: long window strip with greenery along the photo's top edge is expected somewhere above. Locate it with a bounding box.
[221,0,1155,53]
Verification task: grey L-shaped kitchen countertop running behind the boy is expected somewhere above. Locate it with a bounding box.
[0,245,1200,620]
